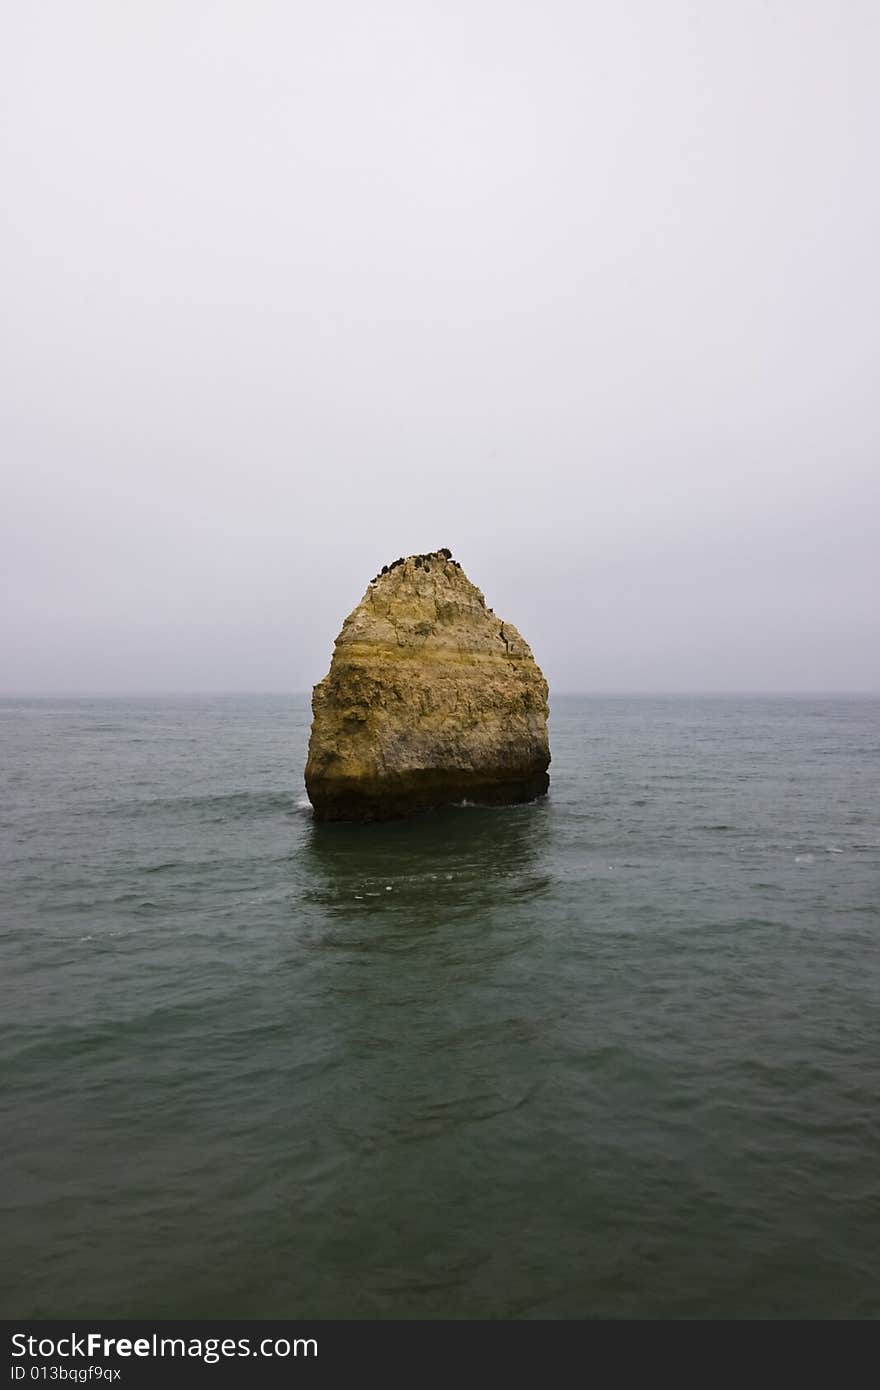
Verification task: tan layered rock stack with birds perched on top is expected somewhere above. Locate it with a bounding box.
[306,550,551,820]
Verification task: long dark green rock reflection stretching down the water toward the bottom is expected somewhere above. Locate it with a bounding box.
[279,802,556,1316]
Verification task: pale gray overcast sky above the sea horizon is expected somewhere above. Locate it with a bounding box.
[0,0,880,692]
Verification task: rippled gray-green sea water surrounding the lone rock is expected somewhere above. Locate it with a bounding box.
[0,696,880,1318]
